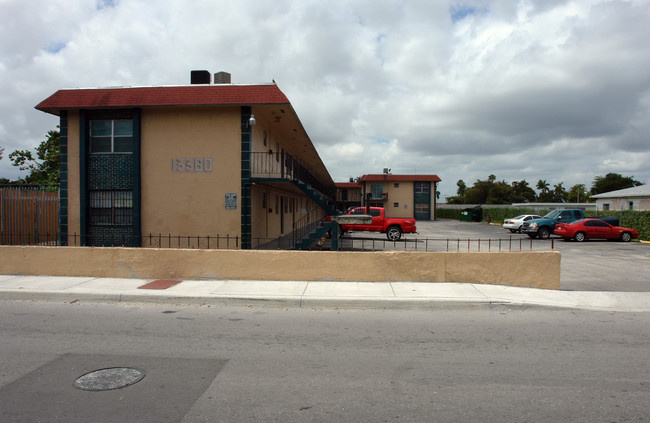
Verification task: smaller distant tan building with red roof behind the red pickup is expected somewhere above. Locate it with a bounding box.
[336,172,440,220]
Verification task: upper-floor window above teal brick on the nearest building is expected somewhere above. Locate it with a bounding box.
[90,119,133,153]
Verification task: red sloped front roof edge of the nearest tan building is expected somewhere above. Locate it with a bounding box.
[36,84,289,113]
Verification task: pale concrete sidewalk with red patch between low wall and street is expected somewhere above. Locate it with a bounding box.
[0,275,650,312]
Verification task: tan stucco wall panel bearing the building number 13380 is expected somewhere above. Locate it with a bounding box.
[141,107,241,237]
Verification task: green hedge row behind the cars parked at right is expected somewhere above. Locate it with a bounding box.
[436,207,650,240]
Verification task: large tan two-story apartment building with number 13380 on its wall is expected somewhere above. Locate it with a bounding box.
[36,71,335,249]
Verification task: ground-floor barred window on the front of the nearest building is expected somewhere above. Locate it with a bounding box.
[89,191,133,226]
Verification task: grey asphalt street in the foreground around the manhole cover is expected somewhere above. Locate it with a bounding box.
[0,301,650,423]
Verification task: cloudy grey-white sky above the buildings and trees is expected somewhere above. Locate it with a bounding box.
[0,0,650,197]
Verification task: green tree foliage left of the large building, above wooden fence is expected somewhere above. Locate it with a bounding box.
[9,127,61,185]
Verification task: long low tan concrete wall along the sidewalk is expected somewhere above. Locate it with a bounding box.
[0,246,560,289]
